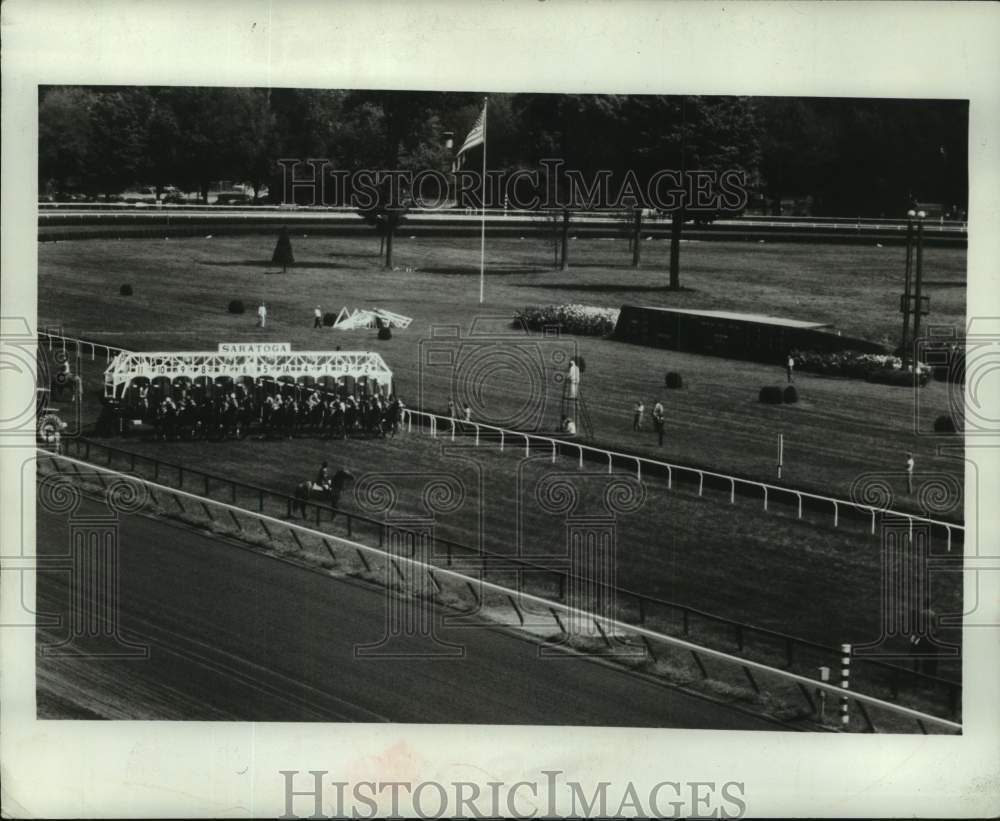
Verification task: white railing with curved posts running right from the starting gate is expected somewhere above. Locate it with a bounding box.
[403,409,965,552]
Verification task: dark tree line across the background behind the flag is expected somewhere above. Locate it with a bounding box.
[38,86,968,217]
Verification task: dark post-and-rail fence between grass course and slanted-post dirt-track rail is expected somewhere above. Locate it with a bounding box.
[56,437,962,716]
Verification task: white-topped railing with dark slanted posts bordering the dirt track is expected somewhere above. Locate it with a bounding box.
[39,451,962,733]
